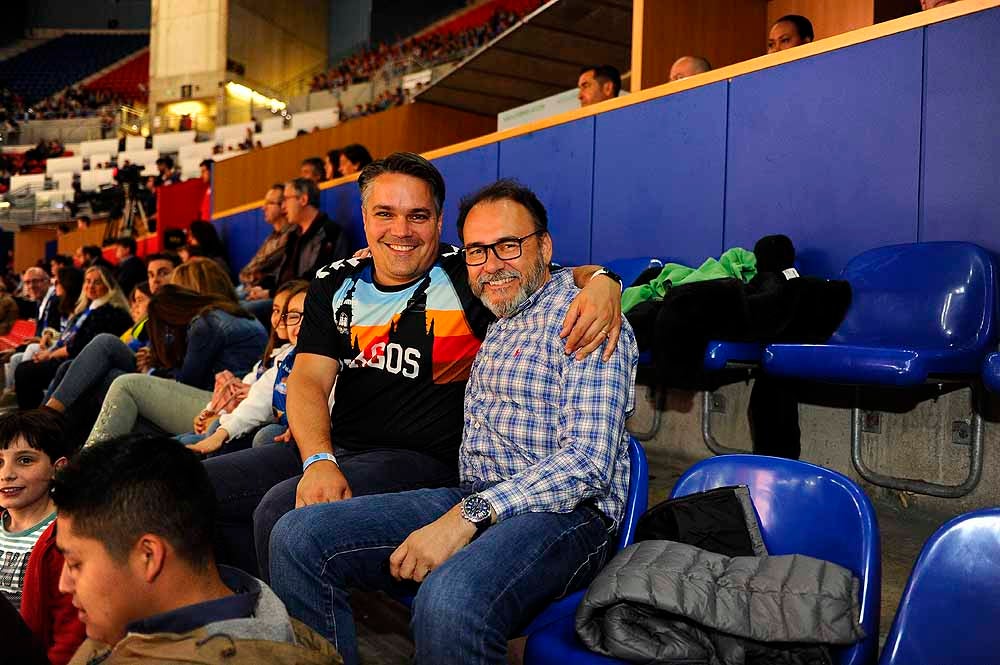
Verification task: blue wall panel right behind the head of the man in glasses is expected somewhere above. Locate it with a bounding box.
[500,117,594,266]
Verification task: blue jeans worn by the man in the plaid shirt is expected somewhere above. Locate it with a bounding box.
[271,488,610,665]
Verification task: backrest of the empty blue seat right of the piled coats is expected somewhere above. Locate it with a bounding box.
[830,242,996,351]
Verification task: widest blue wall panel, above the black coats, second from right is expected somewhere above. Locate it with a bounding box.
[725,30,923,276]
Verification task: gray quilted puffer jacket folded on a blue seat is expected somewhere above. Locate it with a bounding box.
[576,540,864,665]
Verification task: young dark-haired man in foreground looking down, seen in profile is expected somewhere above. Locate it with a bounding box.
[52,436,341,665]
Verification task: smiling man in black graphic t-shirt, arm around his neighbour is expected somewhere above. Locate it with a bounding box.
[205,153,621,579]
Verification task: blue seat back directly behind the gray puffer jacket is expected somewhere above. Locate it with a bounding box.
[671,455,882,665]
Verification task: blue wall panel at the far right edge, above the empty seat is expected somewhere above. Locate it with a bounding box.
[920,9,1000,253]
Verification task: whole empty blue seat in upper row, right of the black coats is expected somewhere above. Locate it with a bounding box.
[763,242,996,386]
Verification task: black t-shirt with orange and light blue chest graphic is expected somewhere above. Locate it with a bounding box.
[296,245,495,464]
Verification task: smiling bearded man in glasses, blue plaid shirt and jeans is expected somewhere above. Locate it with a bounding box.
[271,180,637,665]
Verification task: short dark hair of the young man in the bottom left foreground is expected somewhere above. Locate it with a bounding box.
[52,434,215,570]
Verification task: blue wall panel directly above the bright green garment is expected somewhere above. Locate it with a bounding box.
[592,82,727,265]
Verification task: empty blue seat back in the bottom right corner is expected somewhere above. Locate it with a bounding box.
[879,508,1000,665]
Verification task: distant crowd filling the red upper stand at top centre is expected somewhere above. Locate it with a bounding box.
[310,9,523,92]
